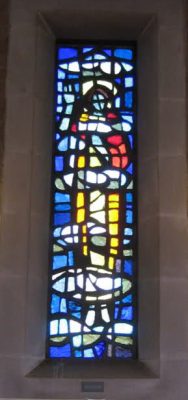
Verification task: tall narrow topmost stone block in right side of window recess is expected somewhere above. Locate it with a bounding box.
[137,19,158,162]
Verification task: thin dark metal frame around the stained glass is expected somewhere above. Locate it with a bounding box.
[46,39,138,365]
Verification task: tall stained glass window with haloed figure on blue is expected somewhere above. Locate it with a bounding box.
[47,43,136,359]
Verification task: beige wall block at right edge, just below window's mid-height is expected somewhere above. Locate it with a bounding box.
[160,216,188,278]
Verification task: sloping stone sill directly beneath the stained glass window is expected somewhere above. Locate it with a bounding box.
[26,360,159,379]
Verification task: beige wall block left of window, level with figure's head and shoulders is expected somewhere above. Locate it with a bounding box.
[5,94,33,153]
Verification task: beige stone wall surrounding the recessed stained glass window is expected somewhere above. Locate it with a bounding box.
[0,0,188,400]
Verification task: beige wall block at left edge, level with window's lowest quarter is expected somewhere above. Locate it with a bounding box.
[0,274,26,355]
